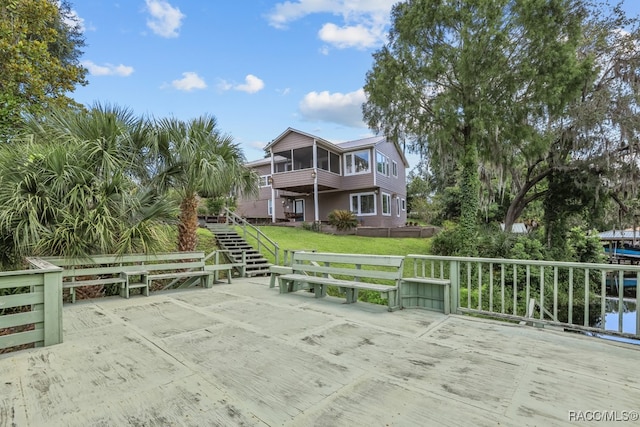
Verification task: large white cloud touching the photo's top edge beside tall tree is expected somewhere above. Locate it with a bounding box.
[267,0,397,49]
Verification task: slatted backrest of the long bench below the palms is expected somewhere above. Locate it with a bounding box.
[41,252,205,278]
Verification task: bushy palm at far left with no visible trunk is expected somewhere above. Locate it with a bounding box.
[0,106,175,262]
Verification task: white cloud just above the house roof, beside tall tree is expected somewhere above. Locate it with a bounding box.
[299,89,366,127]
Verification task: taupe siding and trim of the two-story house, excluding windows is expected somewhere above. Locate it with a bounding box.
[238,128,408,227]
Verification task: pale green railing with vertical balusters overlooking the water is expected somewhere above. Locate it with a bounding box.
[410,255,640,339]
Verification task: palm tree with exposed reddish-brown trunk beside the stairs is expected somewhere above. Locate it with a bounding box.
[155,115,258,251]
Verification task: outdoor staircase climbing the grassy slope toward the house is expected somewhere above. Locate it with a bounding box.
[207,223,271,277]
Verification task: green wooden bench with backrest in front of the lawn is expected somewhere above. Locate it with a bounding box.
[277,252,404,311]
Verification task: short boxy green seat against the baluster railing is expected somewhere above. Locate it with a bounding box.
[400,254,451,314]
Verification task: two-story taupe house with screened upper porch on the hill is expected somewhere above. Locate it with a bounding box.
[237,128,409,227]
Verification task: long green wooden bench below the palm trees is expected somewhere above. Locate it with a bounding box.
[41,251,244,302]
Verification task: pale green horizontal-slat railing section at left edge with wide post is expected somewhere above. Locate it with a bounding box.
[0,261,62,349]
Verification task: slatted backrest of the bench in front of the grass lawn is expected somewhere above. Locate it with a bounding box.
[291,252,404,283]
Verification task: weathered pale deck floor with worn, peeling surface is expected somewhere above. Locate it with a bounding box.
[0,278,640,427]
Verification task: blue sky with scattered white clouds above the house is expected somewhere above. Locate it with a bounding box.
[70,0,640,166]
